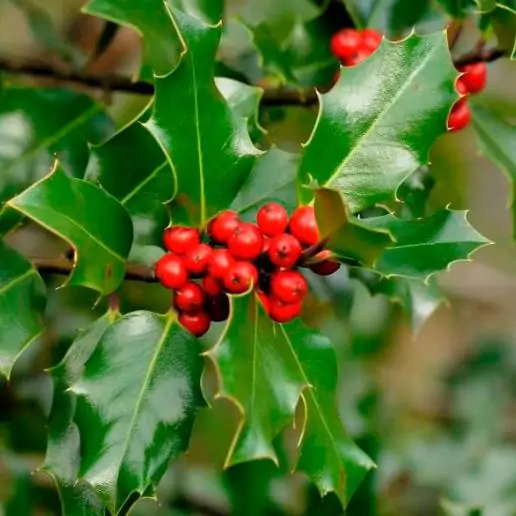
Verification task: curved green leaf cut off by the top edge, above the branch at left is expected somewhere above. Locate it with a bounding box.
[82,0,183,76]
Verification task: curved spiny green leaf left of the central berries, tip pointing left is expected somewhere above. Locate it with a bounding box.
[6,164,133,295]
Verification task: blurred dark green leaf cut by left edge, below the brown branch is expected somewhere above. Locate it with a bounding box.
[0,88,113,203]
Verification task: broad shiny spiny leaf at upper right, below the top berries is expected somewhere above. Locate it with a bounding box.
[299,32,457,213]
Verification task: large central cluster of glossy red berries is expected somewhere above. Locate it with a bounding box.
[156,203,340,336]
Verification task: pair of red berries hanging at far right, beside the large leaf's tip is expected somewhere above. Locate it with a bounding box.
[448,63,487,131]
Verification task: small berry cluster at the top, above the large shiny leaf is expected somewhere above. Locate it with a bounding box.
[331,29,382,66]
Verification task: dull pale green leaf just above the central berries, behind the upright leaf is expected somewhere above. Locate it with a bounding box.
[231,147,299,220]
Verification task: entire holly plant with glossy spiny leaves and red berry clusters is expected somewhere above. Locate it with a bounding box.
[0,0,516,516]
